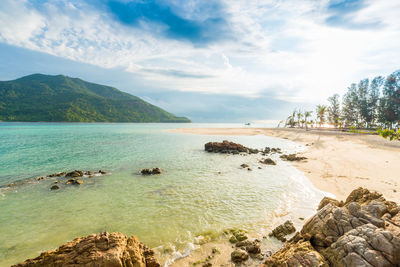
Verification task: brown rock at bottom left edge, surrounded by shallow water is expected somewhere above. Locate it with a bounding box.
[14,232,160,267]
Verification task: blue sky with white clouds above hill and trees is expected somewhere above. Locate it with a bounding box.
[0,0,400,122]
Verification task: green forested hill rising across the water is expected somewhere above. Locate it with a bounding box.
[0,74,190,122]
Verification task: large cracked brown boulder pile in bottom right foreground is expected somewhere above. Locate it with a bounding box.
[264,188,400,267]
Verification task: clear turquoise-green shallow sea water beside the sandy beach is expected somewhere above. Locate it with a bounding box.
[0,123,323,266]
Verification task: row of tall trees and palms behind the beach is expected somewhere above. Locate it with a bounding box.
[285,70,400,131]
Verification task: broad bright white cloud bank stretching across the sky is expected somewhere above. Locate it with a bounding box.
[0,0,400,102]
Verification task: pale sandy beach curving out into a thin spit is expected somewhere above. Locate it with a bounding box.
[170,128,400,202]
